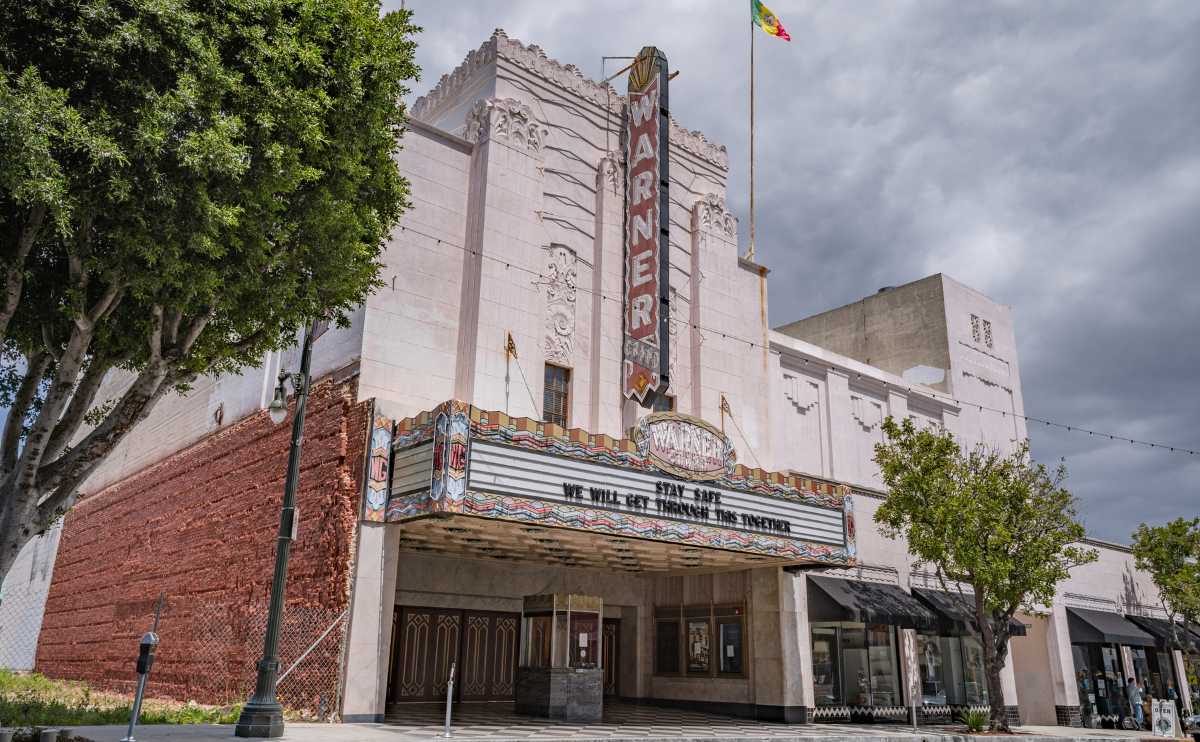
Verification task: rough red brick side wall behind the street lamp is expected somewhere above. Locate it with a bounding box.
[36,378,370,707]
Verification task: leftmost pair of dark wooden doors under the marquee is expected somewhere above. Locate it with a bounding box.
[389,608,462,702]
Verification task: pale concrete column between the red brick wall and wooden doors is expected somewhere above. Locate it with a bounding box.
[342,522,400,722]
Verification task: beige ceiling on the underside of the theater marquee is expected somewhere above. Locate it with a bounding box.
[395,515,803,574]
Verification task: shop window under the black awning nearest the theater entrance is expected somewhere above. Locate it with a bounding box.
[812,622,901,706]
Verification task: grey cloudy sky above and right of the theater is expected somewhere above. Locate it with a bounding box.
[390,0,1200,541]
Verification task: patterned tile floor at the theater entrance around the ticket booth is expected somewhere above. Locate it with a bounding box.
[386,701,916,741]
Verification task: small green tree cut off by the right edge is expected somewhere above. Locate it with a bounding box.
[1133,517,1200,648]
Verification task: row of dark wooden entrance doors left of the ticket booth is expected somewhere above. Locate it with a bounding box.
[388,606,521,704]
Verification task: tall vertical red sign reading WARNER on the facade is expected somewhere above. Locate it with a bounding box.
[622,47,671,403]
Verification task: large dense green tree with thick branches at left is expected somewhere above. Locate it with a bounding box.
[0,0,419,579]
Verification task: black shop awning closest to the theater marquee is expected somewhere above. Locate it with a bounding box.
[809,575,941,629]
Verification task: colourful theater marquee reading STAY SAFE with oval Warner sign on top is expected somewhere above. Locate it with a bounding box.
[386,401,854,564]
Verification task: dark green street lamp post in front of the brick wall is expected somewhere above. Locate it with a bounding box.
[234,322,317,737]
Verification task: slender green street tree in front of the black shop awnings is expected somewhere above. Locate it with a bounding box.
[875,418,1097,730]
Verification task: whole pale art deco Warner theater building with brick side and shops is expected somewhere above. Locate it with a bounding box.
[16,31,1194,724]
